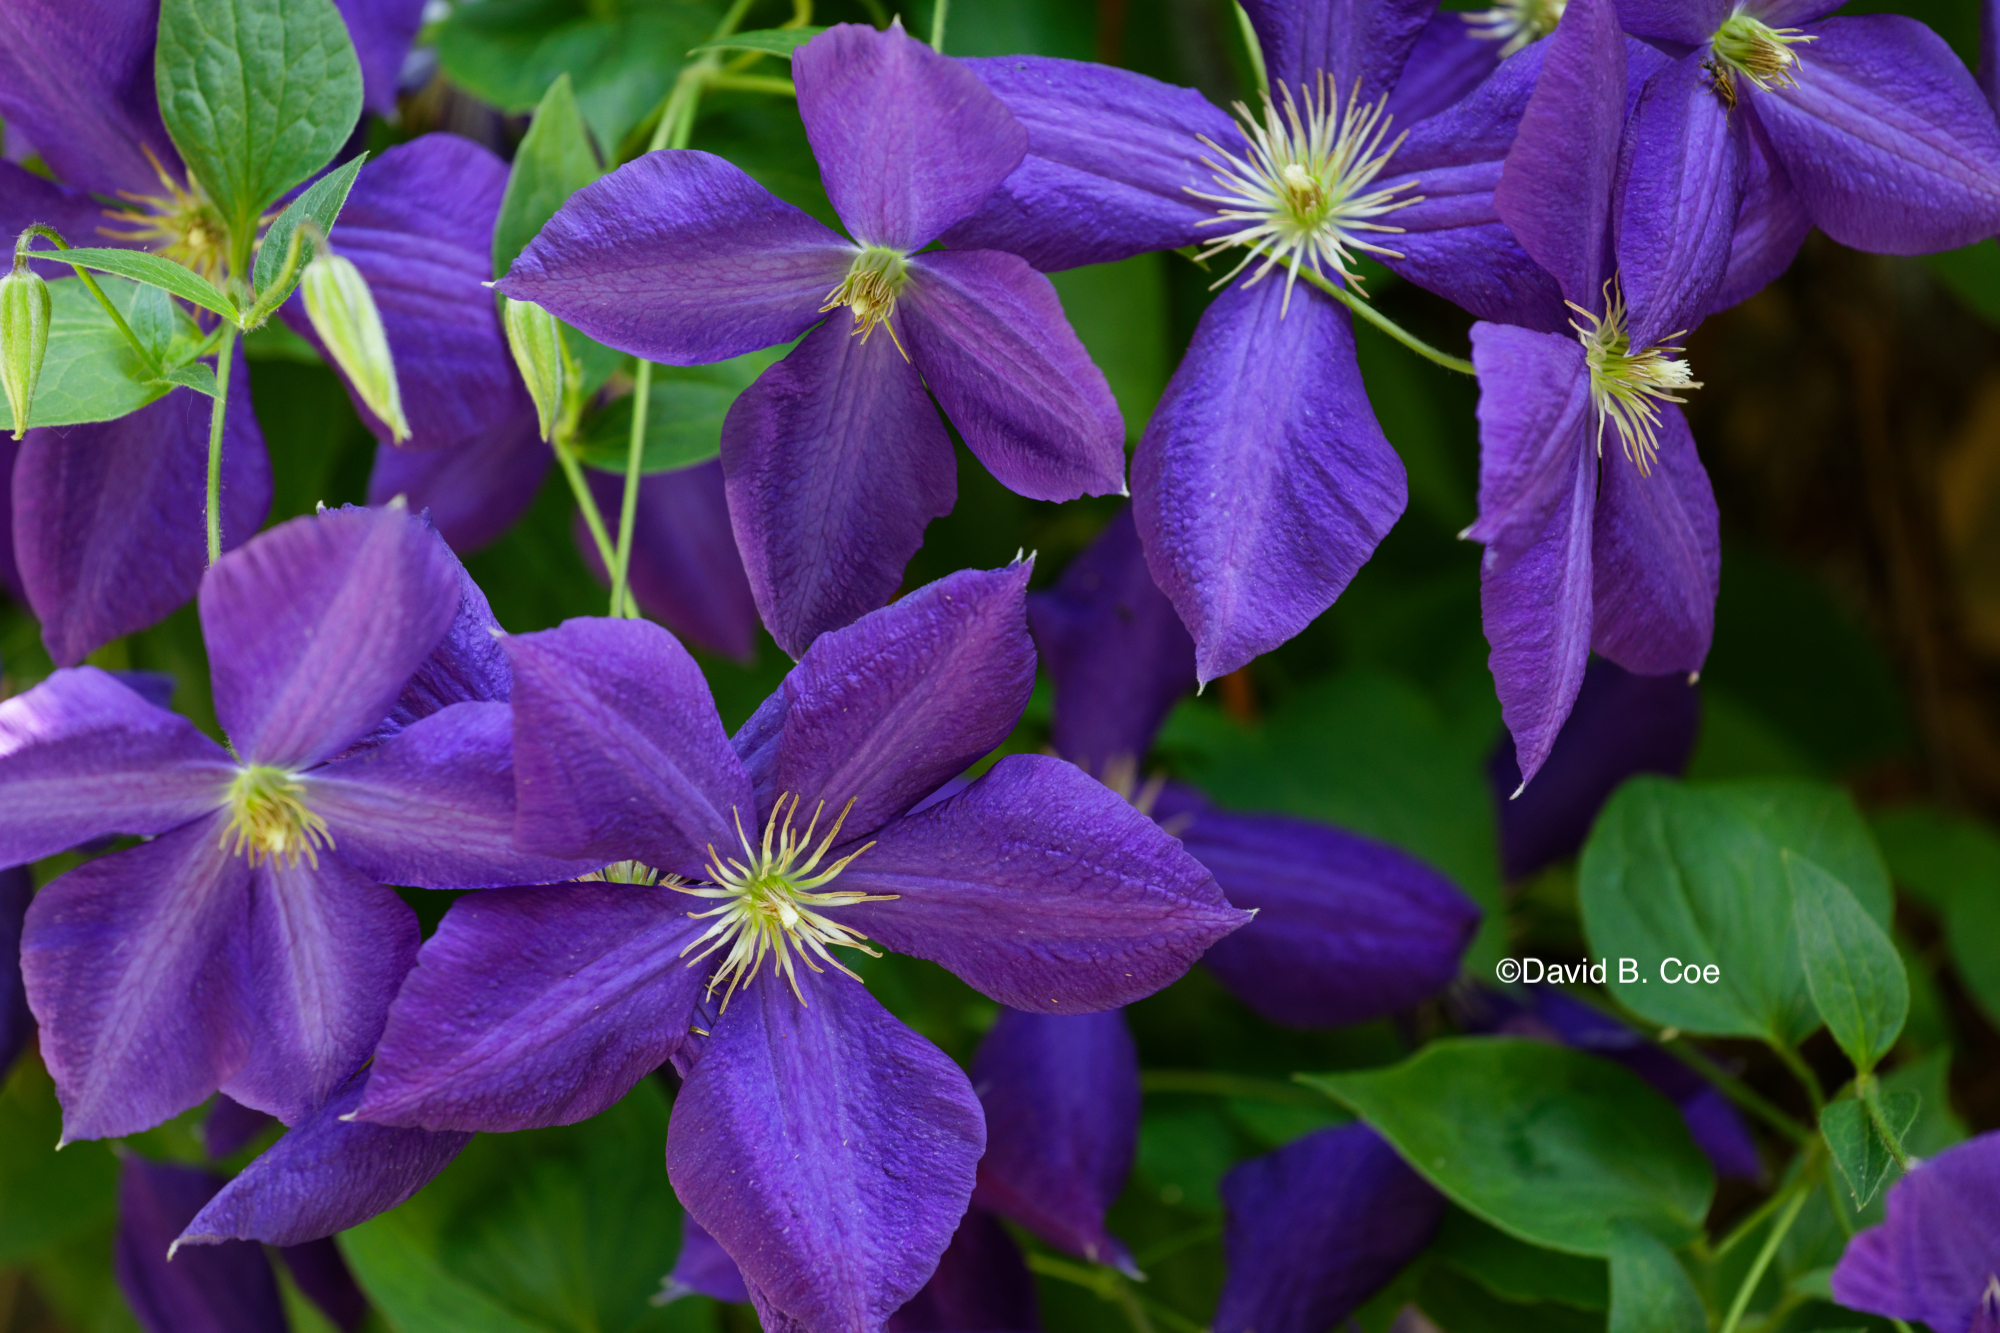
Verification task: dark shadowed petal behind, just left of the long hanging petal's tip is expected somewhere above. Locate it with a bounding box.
[1028,506,1194,777]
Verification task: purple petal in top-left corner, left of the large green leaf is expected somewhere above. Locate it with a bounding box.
[0,0,182,196]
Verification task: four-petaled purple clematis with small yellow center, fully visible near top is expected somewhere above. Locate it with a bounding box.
[500,24,1124,656]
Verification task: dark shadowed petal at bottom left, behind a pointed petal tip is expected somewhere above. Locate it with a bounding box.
[112,1153,290,1333]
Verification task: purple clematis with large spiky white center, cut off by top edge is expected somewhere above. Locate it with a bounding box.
[946,0,1560,681]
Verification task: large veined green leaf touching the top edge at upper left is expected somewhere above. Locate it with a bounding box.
[154,0,362,241]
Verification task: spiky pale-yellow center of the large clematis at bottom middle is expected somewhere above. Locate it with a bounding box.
[674,793,896,1009]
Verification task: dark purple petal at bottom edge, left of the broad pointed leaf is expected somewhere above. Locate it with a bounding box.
[1214,1123,1444,1333]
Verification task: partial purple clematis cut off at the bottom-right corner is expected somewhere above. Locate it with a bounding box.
[1832,1133,2000,1333]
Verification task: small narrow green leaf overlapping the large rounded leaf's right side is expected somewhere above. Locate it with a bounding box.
[1784,849,1910,1073]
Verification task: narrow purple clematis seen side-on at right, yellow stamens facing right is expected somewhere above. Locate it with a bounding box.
[1466,0,1744,783]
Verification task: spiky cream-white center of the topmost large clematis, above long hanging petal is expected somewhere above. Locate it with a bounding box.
[1188,74,1422,306]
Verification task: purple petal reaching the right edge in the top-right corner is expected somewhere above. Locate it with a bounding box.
[1746,14,2000,254]
